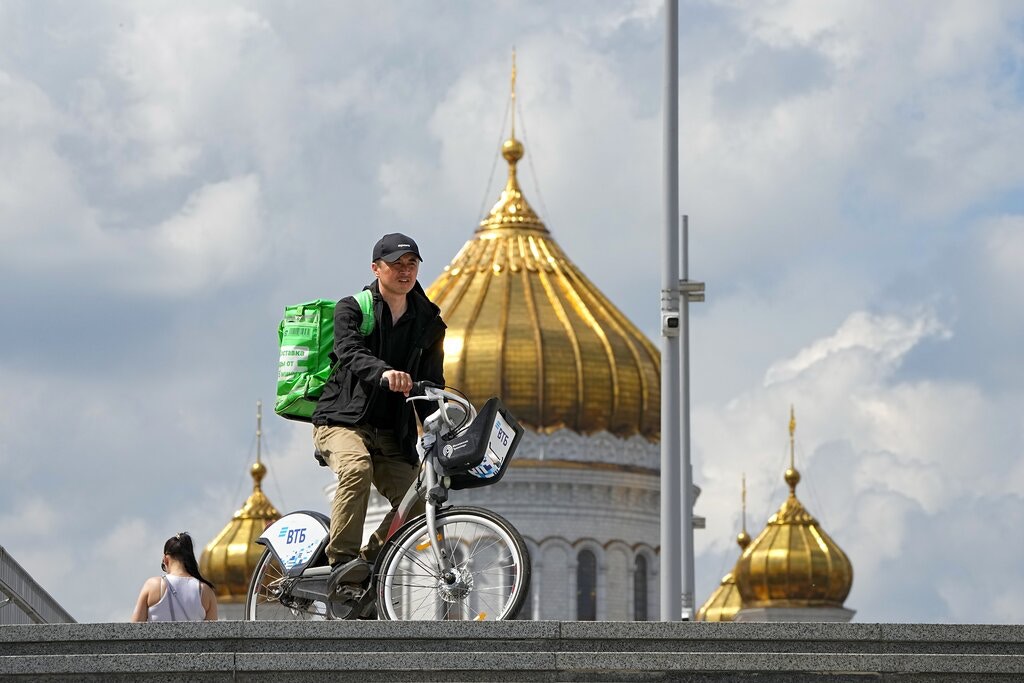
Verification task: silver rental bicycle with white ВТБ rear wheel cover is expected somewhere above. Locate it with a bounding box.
[245,382,530,621]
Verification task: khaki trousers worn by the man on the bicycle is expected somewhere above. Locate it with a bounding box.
[313,426,424,564]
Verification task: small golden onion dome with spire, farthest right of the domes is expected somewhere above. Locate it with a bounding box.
[735,411,853,608]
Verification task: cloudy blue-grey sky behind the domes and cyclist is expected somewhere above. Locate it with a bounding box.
[0,0,1024,623]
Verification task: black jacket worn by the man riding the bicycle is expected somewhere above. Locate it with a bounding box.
[312,281,445,464]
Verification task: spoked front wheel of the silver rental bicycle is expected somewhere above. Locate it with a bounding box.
[377,507,530,621]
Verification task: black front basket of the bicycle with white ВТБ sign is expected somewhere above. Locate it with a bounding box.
[436,397,523,490]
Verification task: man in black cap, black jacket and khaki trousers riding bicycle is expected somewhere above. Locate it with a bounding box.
[312,232,445,585]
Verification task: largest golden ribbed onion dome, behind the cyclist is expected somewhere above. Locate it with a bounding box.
[427,135,660,440]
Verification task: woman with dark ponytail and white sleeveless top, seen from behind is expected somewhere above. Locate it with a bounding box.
[131,531,217,622]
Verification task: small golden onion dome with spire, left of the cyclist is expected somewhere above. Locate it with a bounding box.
[199,403,281,603]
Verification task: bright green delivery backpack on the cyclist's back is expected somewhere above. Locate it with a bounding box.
[273,290,376,422]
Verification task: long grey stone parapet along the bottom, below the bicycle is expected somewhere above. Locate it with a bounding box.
[0,622,1024,683]
